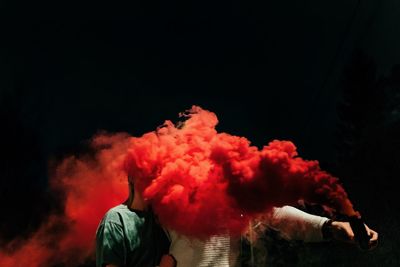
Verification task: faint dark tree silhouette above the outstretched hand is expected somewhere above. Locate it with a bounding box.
[336,50,385,206]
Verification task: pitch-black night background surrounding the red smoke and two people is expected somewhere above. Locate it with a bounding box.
[0,0,400,266]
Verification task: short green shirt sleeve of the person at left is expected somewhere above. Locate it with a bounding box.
[96,221,126,267]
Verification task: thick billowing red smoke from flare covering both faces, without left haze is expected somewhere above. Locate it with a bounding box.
[125,107,355,238]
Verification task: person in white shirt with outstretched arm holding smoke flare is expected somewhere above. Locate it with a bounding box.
[170,206,378,267]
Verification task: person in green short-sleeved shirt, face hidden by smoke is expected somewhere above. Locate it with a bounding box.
[96,179,176,267]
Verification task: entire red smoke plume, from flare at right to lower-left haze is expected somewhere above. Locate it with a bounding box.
[0,106,357,267]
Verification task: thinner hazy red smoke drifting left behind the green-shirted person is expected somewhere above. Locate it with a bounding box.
[0,134,129,267]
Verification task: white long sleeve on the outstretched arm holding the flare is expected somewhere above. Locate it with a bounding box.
[266,206,329,242]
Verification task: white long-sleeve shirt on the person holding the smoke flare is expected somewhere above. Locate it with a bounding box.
[170,206,328,267]
